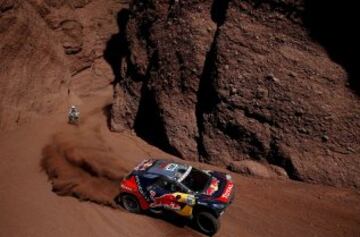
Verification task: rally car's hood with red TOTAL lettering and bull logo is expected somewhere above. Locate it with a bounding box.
[203,171,234,203]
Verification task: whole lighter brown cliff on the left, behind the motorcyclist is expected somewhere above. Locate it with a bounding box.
[0,0,124,131]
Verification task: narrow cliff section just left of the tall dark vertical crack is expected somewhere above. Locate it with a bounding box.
[113,1,216,160]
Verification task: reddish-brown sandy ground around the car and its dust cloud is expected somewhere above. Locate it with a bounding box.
[0,88,360,236]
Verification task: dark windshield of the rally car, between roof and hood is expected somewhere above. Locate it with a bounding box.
[181,168,210,192]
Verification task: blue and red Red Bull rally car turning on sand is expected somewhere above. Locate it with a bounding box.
[115,159,234,235]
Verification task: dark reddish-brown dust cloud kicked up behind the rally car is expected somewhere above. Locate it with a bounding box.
[41,129,127,207]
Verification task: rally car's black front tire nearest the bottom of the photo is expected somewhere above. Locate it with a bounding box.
[195,211,220,236]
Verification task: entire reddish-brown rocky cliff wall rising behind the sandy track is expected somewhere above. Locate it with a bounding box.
[0,0,360,188]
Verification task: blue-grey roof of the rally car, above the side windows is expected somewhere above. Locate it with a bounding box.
[139,159,191,181]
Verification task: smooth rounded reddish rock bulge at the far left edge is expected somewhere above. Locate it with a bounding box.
[0,1,69,130]
